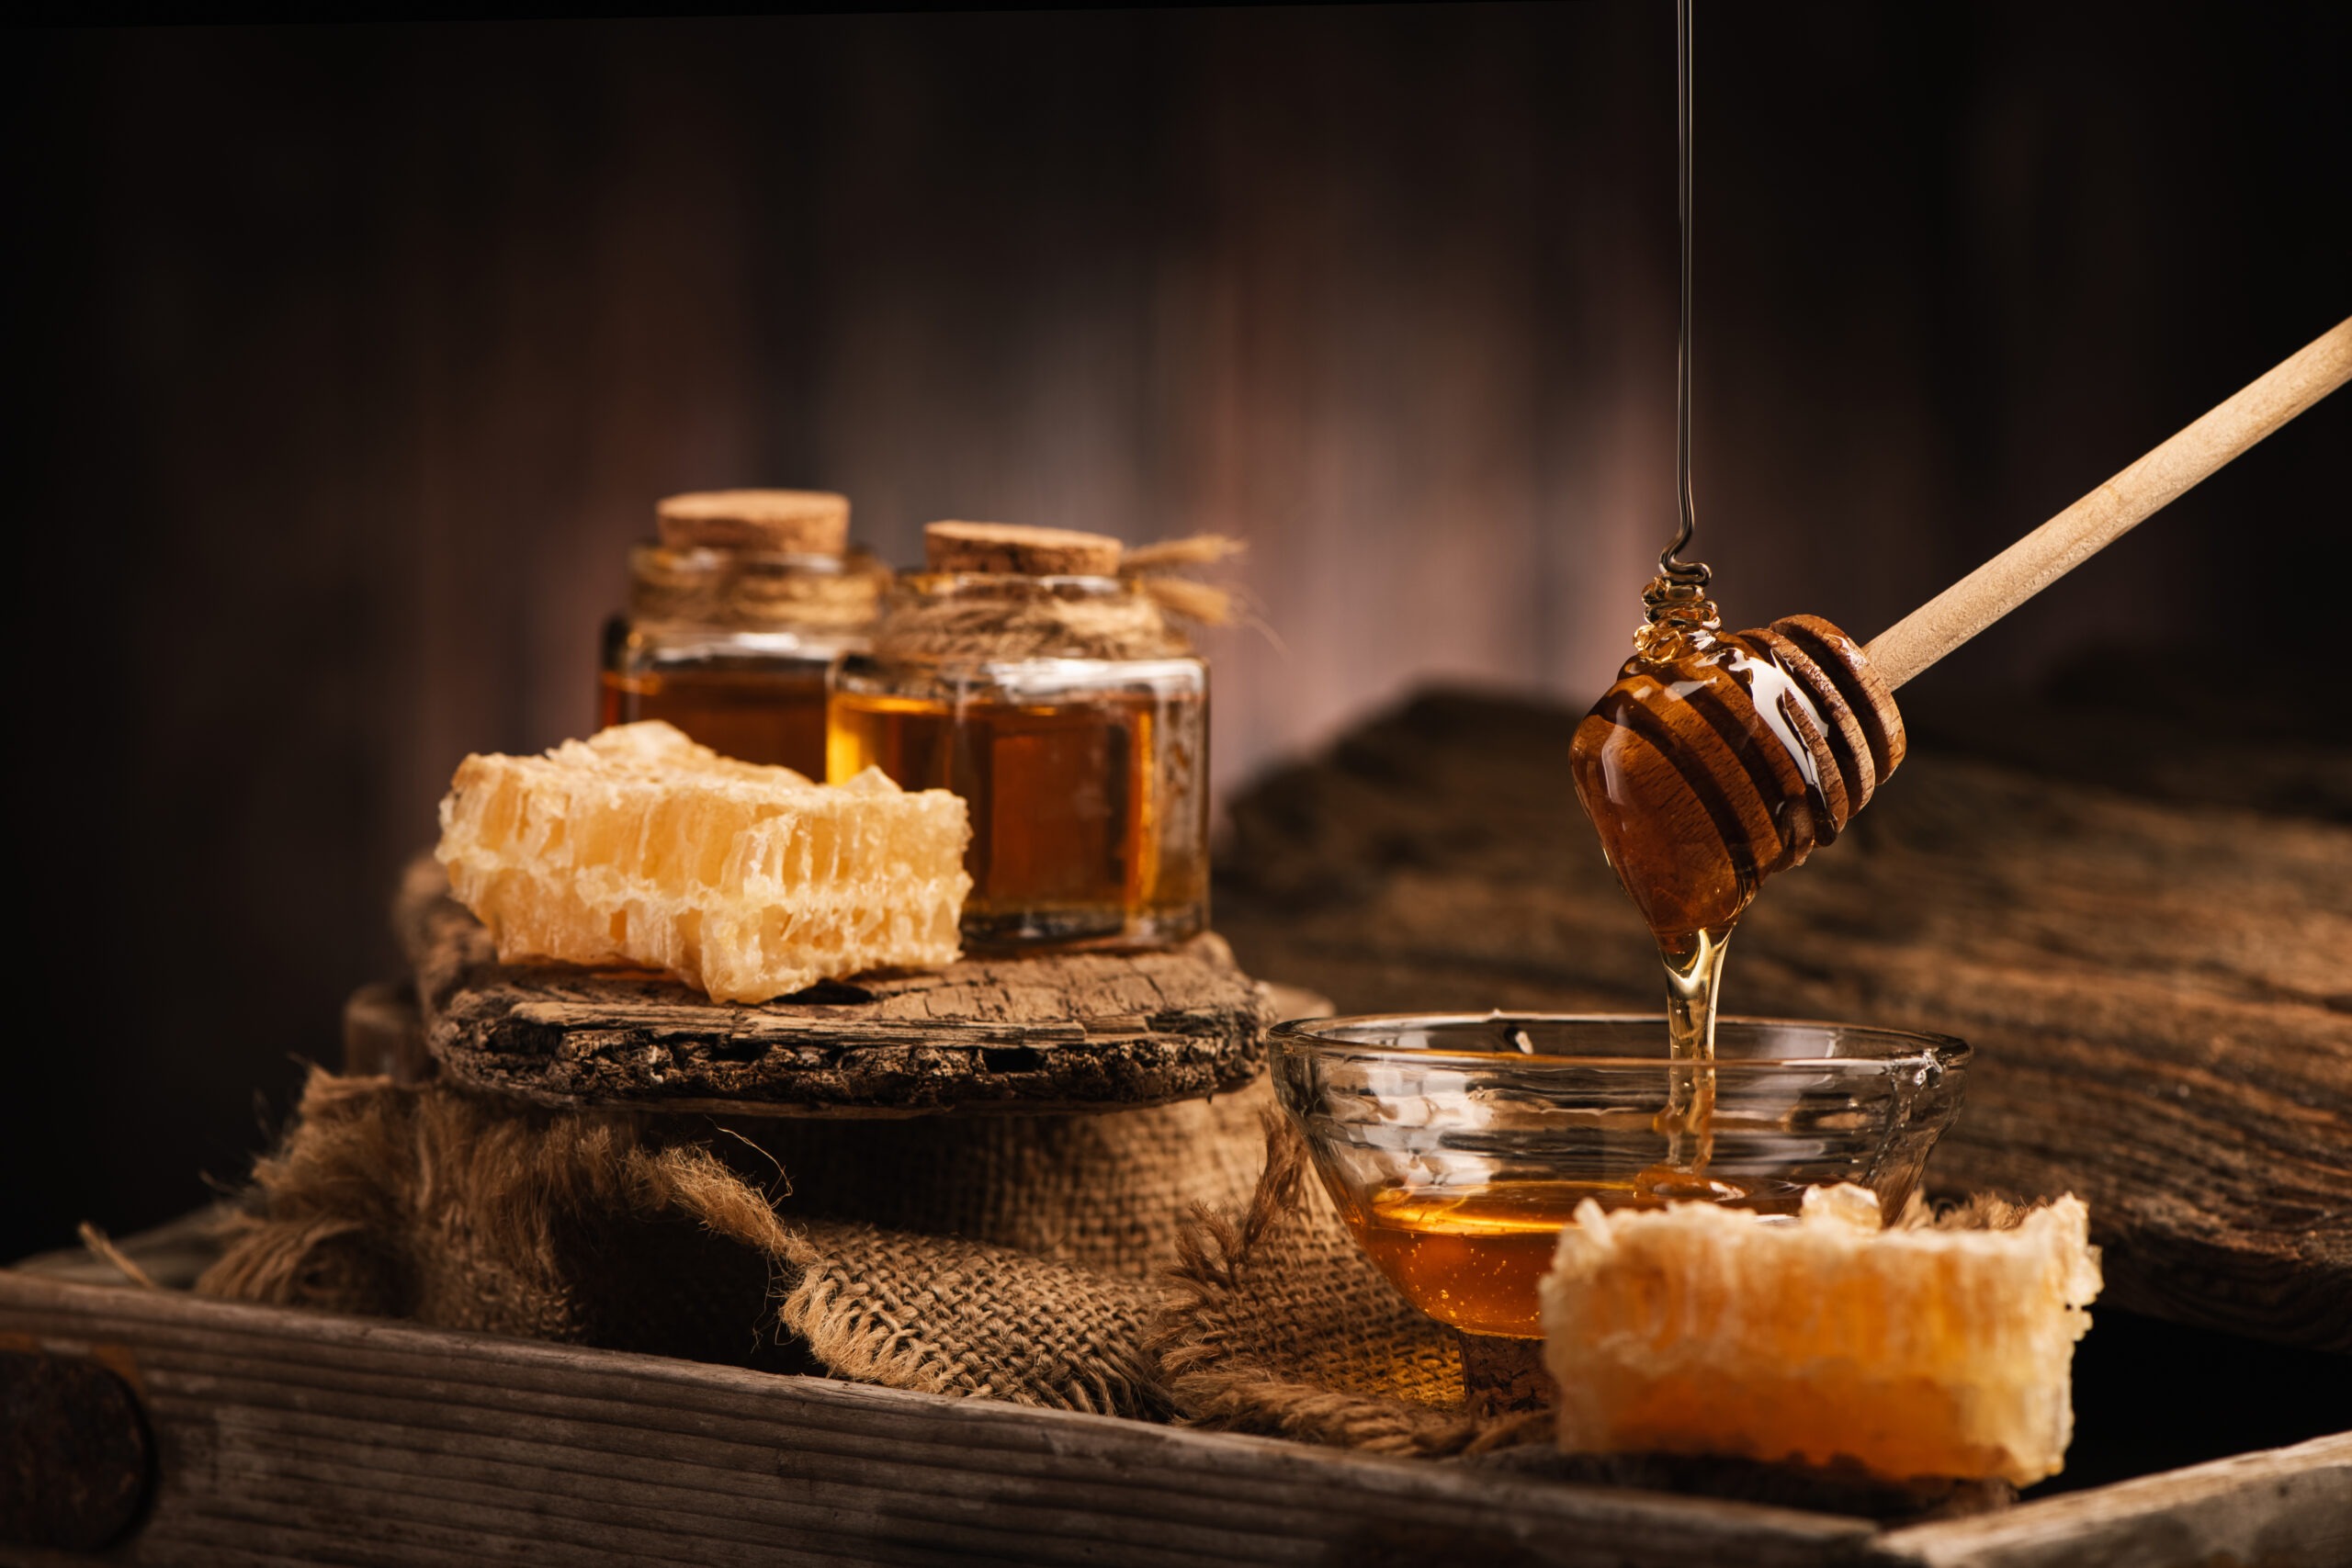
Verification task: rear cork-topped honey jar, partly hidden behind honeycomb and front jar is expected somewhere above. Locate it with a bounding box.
[600,489,887,778]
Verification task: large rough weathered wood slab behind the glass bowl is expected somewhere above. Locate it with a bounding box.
[1218,694,2352,1349]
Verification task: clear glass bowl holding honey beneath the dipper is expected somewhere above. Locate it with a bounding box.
[1272,1013,1969,1337]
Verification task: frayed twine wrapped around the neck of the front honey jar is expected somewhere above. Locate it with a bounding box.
[873,534,1244,663]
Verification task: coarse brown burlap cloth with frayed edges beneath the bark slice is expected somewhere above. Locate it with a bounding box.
[198,1053,1448,1453]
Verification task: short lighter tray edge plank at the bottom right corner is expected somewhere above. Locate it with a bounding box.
[1877,1438,2352,1568]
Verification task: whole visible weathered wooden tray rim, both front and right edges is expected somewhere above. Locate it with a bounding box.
[0,1269,2352,1568]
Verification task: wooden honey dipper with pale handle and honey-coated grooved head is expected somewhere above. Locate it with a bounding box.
[1571,320,2352,945]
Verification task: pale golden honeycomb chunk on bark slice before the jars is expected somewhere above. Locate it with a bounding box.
[435,722,971,1001]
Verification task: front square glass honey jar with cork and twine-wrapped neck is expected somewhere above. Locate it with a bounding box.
[828,522,1209,950]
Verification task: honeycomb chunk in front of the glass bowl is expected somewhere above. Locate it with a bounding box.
[1541,1187,2098,1485]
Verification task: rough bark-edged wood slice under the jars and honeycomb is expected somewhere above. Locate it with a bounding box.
[395,861,1277,1117]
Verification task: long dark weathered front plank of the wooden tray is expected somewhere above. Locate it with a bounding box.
[0,1274,1870,1568]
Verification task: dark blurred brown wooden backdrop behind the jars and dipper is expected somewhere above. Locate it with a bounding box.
[0,0,2352,1256]
